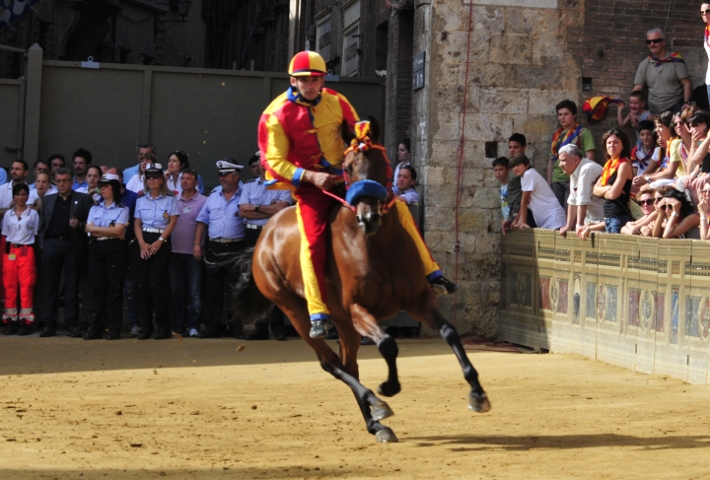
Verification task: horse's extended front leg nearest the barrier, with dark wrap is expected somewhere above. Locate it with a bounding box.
[409,300,491,413]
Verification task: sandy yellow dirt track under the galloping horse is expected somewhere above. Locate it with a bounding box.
[0,336,710,480]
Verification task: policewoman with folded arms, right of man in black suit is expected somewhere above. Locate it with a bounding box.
[84,173,129,340]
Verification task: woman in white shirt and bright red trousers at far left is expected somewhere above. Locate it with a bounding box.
[2,183,39,335]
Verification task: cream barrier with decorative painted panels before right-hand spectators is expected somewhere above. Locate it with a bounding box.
[499,229,710,384]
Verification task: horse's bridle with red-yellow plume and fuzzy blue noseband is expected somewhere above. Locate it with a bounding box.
[343,121,397,215]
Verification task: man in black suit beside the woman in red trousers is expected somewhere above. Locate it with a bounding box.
[39,168,93,338]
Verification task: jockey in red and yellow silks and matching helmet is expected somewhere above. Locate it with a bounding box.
[259,51,458,338]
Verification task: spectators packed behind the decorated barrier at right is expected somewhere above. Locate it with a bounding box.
[493,22,710,240]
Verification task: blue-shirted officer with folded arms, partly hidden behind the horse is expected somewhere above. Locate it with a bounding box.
[239,152,291,341]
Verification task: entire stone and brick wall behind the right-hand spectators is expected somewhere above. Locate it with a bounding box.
[410,0,707,335]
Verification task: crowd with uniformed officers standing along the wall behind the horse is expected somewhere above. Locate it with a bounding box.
[0,139,419,340]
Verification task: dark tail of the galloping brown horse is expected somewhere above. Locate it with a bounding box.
[232,248,274,323]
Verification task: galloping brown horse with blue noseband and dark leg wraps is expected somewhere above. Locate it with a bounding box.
[235,121,490,442]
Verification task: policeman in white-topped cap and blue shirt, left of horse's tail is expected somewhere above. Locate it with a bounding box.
[193,159,244,338]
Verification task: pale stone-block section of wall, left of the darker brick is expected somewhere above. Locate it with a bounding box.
[414,0,582,336]
